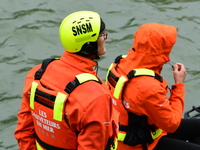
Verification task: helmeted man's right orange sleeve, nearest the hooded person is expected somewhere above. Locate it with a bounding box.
[75,95,116,150]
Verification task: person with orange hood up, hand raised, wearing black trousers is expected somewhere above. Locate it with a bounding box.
[106,22,200,150]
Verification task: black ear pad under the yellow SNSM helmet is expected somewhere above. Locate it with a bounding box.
[80,42,98,55]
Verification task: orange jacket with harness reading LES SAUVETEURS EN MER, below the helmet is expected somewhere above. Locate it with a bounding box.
[15,52,117,150]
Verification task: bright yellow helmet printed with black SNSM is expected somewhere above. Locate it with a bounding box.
[59,11,105,53]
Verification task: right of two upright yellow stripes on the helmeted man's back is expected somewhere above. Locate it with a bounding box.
[53,92,67,121]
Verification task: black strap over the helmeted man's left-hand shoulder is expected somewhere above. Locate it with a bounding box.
[35,58,56,80]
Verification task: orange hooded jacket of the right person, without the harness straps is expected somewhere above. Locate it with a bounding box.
[107,23,184,150]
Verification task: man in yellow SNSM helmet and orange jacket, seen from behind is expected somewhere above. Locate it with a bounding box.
[14,11,118,150]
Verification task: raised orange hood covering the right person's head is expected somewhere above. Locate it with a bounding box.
[119,23,177,74]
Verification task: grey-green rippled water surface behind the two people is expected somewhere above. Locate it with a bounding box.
[0,0,200,150]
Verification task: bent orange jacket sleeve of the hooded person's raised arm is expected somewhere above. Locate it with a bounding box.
[143,83,184,133]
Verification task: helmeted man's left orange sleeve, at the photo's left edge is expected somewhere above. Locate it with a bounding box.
[14,77,36,150]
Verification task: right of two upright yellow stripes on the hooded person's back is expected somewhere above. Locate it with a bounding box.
[113,76,127,99]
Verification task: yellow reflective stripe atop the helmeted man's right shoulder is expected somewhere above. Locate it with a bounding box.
[76,73,99,84]
